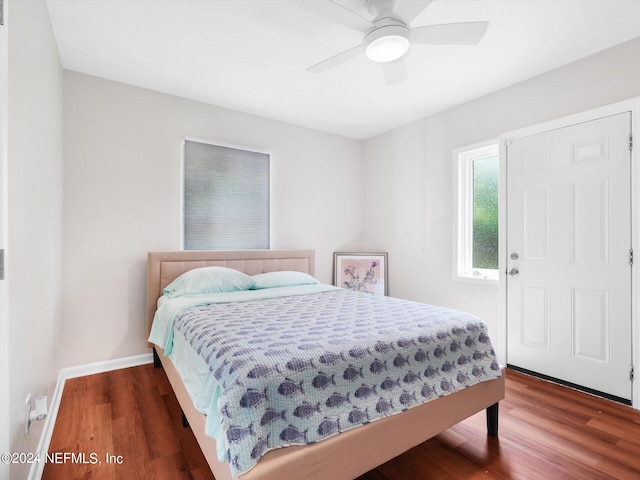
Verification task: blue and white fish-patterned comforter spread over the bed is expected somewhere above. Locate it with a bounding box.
[158,289,501,474]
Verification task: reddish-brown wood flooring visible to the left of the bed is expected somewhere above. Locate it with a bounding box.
[42,365,214,480]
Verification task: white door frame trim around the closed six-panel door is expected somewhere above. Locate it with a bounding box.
[497,97,640,410]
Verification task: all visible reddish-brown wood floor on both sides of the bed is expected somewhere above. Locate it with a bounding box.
[43,365,640,480]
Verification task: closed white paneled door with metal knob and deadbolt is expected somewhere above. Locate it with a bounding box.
[506,112,632,400]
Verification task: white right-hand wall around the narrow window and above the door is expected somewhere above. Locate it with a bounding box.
[364,39,640,353]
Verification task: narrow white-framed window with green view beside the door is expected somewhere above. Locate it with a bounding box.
[454,143,498,281]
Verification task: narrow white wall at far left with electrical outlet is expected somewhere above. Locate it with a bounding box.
[3,1,62,479]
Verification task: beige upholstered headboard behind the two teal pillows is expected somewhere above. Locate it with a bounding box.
[147,250,315,336]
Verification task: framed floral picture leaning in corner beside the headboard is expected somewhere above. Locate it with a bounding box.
[333,252,387,295]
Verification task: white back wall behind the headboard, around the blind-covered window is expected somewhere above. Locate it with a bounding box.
[59,71,364,366]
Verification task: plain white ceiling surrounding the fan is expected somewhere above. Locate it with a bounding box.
[47,0,640,139]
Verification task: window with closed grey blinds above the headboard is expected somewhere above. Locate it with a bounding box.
[184,140,269,250]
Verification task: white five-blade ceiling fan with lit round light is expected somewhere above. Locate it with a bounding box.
[300,0,489,85]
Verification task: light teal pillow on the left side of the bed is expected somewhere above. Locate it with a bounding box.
[162,267,254,298]
